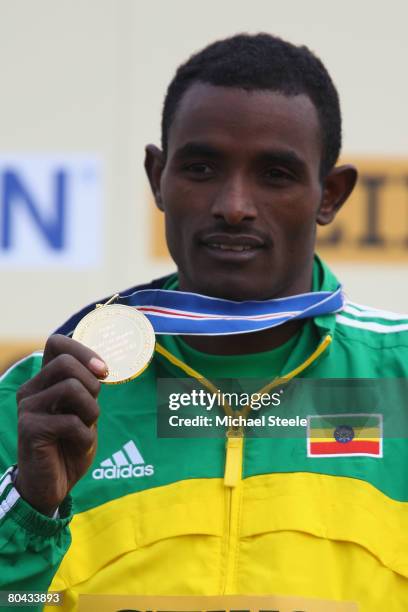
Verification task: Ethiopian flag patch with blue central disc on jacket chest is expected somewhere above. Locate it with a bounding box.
[307,413,383,457]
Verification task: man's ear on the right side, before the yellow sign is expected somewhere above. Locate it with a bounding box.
[316,165,358,225]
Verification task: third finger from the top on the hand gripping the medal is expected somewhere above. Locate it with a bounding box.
[19,378,99,427]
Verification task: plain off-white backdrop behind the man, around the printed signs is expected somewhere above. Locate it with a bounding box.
[0,0,408,339]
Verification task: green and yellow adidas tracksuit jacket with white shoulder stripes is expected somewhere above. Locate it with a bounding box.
[0,259,408,612]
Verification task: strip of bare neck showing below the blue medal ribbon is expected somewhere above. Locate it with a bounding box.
[182,320,305,355]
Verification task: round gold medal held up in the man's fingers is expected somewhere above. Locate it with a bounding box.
[72,296,155,385]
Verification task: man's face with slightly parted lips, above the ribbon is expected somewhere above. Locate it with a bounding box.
[159,83,322,300]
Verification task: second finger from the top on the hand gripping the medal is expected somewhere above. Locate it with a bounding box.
[17,353,101,402]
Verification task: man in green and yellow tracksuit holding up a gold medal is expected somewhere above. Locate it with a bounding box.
[0,34,408,612]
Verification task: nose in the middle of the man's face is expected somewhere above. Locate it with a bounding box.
[211,176,256,225]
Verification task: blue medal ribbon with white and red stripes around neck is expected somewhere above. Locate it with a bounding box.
[119,285,344,336]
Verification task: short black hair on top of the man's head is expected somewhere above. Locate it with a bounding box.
[162,33,341,177]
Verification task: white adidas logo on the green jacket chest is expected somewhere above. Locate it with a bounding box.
[92,440,154,480]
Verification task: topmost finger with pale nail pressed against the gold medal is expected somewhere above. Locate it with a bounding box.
[43,334,108,378]
